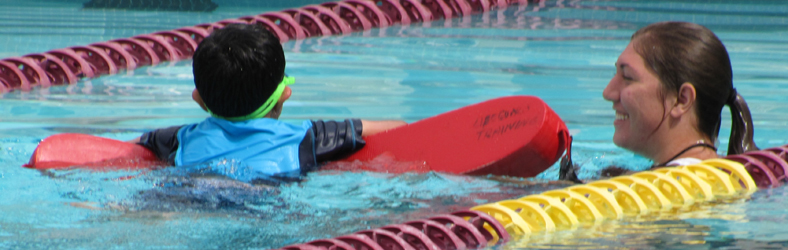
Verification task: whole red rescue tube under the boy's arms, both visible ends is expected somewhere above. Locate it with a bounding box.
[25,96,571,177]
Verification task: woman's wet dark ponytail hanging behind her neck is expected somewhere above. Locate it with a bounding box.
[725,88,758,155]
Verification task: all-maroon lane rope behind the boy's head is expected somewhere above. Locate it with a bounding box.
[0,0,543,94]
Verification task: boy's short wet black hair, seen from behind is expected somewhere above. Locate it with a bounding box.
[192,24,285,117]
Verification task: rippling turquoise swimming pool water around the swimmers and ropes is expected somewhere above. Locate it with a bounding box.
[0,1,788,249]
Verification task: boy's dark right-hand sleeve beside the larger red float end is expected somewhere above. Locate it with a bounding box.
[312,119,366,163]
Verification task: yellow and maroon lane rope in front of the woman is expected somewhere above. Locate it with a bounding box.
[281,145,788,250]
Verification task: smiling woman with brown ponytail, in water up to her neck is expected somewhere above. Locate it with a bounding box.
[561,22,757,179]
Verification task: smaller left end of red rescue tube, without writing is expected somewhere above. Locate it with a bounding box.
[24,133,166,170]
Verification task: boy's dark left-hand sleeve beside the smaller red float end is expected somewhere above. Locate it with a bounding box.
[137,126,182,165]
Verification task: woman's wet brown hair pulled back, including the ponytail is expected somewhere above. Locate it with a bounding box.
[631,22,758,154]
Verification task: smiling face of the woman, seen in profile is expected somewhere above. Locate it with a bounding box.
[602,41,667,154]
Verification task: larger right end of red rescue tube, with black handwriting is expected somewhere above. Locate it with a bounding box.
[346,96,569,177]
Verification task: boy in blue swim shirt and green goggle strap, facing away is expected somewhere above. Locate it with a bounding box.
[132,24,405,182]
